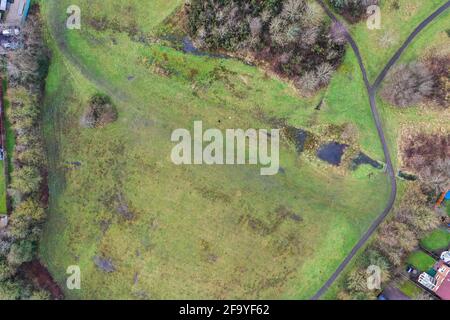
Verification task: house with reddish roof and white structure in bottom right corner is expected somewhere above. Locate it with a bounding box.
[418,260,450,300]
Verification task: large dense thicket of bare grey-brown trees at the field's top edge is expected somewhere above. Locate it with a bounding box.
[188,0,344,93]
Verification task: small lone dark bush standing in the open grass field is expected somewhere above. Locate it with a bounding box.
[82,94,117,128]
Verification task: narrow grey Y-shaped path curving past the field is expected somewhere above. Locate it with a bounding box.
[311,0,450,300]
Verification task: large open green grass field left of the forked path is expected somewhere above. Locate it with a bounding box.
[40,0,448,299]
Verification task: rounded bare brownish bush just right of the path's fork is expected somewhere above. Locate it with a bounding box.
[381,63,435,108]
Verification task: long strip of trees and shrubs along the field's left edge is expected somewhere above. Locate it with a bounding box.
[0,7,49,299]
